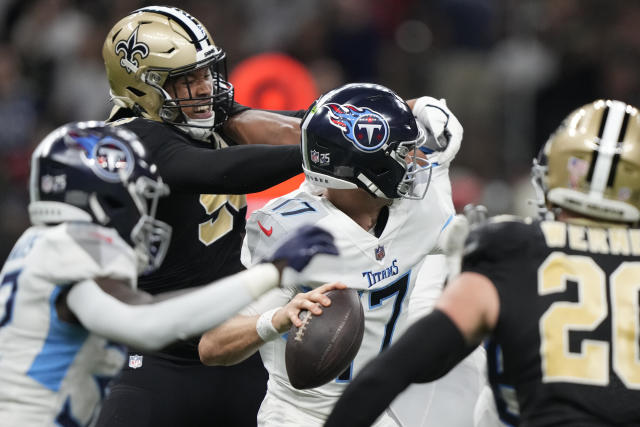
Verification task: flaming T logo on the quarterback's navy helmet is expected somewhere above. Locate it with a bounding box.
[325,104,389,152]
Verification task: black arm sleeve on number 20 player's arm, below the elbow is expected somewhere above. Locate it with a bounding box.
[325,309,475,427]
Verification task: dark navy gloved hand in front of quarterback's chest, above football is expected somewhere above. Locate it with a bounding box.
[268,225,338,288]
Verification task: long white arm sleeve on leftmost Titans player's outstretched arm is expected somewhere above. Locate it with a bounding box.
[67,263,279,350]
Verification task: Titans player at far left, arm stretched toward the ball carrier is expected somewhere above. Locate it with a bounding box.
[0,122,336,426]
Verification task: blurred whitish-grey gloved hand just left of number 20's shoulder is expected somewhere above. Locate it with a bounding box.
[440,204,488,279]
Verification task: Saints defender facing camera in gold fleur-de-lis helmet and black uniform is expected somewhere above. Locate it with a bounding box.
[98,6,312,427]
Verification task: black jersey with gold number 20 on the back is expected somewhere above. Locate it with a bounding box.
[463,219,640,426]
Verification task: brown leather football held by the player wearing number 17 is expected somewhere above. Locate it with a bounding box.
[285,288,364,389]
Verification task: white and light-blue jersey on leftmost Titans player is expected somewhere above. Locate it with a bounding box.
[0,223,137,426]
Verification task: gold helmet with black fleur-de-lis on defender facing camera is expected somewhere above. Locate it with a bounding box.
[102,6,233,139]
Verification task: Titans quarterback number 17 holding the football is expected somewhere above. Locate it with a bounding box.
[200,84,484,426]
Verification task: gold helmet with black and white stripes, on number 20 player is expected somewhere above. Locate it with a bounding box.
[532,100,640,223]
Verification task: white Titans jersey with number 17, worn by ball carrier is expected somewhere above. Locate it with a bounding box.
[242,168,454,423]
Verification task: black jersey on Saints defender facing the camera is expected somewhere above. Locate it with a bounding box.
[106,113,302,359]
